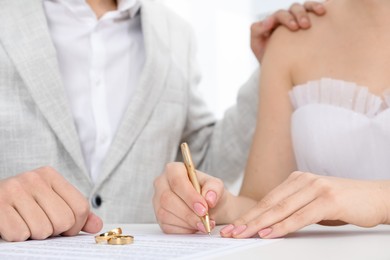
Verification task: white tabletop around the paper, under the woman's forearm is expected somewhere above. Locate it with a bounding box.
[104,224,390,260]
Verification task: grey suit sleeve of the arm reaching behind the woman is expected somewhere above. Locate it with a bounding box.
[178,31,259,184]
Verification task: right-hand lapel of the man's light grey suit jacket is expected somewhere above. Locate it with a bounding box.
[96,1,169,185]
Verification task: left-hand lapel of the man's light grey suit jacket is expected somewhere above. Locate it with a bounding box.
[0,0,88,177]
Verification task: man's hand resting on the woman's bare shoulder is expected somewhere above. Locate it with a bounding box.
[251,1,326,62]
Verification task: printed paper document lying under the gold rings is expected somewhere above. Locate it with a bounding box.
[0,224,277,260]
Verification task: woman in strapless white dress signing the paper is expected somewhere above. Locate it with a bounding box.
[154,0,390,238]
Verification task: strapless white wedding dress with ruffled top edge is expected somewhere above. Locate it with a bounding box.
[290,78,390,179]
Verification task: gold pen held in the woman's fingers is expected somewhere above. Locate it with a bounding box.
[180,143,211,235]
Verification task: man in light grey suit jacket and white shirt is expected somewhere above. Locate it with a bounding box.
[0,0,322,241]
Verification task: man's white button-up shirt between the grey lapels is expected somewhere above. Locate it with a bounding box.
[44,0,145,181]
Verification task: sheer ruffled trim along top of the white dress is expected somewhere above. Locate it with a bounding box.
[289,78,390,117]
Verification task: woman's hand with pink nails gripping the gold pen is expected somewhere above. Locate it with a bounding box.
[153,163,227,234]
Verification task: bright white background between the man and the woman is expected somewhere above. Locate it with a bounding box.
[159,0,303,118]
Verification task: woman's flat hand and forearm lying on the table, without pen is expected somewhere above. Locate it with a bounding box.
[221,172,390,238]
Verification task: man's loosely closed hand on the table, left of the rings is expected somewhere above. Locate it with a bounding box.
[0,167,103,241]
